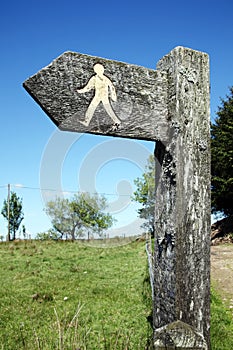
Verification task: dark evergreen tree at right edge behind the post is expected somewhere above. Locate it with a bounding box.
[211,87,233,216]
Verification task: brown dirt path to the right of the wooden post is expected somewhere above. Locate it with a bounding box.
[211,244,233,312]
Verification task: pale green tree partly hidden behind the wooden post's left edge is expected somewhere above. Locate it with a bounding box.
[133,154,155,236]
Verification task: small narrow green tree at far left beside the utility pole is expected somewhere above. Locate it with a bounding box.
[1,192,24,241]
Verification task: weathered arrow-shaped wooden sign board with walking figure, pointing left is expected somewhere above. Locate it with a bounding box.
[23,52,167,141]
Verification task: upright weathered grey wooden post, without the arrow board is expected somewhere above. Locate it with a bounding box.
[154,47,210,349]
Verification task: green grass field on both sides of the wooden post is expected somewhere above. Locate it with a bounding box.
[0,241,233,350]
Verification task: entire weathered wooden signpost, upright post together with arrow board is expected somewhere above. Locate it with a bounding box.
[23,47,210,350]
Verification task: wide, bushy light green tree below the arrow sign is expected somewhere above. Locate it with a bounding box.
[45,193,114,240]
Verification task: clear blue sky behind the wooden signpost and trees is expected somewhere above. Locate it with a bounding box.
[0,0,233,235]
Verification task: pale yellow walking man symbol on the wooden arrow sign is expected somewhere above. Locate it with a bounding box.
[77,63,121,126]
